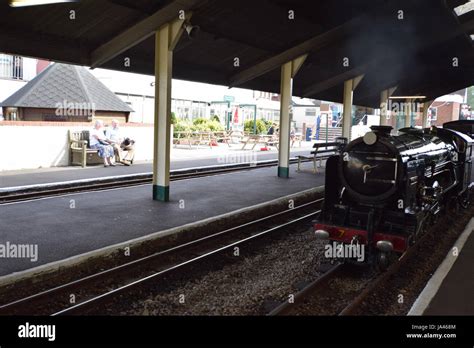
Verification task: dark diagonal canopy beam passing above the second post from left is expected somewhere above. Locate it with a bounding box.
[229,16,365,87]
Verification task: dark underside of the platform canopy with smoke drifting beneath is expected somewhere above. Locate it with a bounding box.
[0,0,474,107]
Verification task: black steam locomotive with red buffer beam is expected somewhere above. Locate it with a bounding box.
[314,121,474,269]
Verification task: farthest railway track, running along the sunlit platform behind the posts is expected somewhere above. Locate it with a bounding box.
[0,158,310,205]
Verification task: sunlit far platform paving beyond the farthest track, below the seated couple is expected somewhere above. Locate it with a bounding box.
[0,148,311,188]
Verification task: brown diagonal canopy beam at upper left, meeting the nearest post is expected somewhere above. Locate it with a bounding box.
[90,0,203,68]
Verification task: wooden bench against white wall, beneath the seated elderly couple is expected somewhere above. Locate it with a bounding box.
[69,130,104,168]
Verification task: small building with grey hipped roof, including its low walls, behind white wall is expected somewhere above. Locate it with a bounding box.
[1,63,133,123]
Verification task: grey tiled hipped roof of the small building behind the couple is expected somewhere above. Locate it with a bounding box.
[0,63,133,112]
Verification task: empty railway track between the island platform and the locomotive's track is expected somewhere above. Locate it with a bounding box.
[0,199,323,315]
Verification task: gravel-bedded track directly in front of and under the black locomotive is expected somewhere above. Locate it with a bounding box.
[268,228,429,316]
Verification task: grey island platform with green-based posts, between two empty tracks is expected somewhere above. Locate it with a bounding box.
[0,157,324,276]
